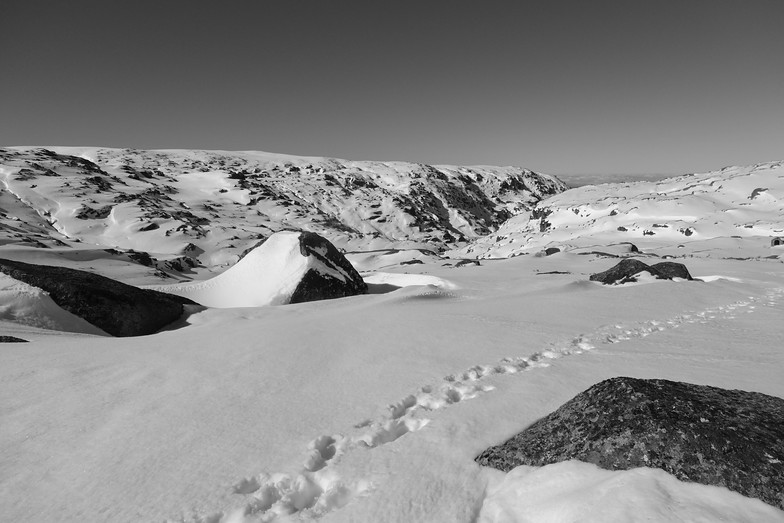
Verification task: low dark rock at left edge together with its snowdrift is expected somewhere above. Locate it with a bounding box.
[0,259,193,336]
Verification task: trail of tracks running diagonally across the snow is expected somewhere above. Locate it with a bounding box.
[197,288,784,523]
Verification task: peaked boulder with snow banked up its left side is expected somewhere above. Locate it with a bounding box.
[150,231,367,308]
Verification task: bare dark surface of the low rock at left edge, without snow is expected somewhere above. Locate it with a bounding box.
[0,259,199,336]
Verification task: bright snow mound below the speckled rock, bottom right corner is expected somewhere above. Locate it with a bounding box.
[478,461,784,523]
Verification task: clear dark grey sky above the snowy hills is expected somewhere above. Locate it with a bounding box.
[0,0,784,174]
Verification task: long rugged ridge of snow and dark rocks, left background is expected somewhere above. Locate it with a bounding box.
[0,147,566,272]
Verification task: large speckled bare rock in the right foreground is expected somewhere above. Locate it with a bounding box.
[476,378,784,509]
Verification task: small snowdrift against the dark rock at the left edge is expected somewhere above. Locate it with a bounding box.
[0,273,108,336]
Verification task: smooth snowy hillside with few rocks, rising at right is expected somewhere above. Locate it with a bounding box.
[450,162,784,258]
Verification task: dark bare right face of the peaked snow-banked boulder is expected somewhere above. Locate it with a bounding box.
[289,232,368,303]
